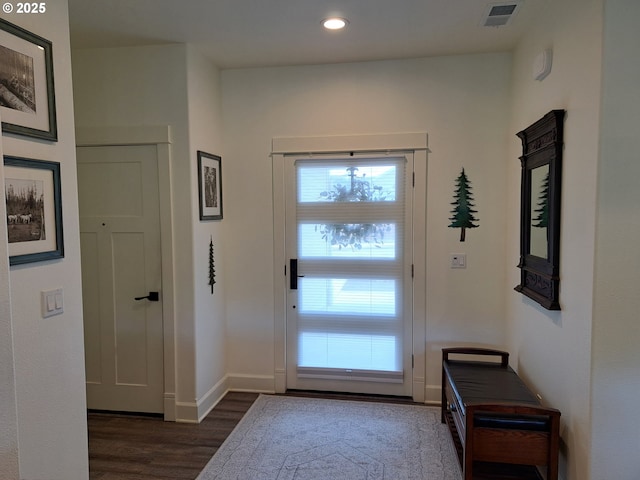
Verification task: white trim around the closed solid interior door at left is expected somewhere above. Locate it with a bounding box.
[76,125,176,421]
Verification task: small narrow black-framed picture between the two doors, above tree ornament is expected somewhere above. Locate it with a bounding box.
[198,151,222,220]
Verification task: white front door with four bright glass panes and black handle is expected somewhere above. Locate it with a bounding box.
[285,155,413,396]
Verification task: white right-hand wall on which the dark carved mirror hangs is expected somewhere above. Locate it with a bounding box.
[507,0,613,480]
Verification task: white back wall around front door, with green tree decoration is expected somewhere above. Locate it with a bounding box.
[222,54,511,401]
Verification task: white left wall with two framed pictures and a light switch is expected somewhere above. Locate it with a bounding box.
[0,0,88,480]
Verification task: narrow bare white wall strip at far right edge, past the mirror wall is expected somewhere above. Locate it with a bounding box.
[589,0,640,480]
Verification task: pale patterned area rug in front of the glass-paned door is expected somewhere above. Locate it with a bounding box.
[197,395,461,480]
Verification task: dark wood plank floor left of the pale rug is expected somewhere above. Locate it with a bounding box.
[88,392,258,480]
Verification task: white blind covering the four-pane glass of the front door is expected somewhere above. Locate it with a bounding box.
[295,157,406,381]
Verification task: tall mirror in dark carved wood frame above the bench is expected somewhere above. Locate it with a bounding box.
[515,110,565,310]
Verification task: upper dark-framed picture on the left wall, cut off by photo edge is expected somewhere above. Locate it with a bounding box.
[0,19,58,141]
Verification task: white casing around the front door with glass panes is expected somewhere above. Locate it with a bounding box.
[271,133,428,402]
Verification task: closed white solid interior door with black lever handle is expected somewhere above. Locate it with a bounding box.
[77,145,164,413]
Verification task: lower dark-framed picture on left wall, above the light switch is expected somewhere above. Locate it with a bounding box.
[4,156,64,265]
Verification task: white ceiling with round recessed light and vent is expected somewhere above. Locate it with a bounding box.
[69,0,550,68]
